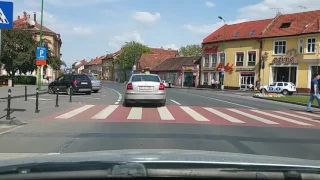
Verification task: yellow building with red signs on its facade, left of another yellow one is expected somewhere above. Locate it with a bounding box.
[200,19,272,89]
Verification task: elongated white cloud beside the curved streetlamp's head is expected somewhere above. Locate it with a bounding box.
[183,19,246,34]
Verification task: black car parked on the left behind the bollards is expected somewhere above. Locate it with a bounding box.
[48,74,92,94]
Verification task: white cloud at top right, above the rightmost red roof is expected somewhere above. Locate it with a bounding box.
[238,0,320,20]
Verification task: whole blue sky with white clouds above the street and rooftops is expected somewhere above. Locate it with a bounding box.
[6,0,320,67]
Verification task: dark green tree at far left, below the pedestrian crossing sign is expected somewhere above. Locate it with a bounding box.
[0,29,38,77]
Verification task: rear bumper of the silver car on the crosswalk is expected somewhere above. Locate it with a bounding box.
[125,93,166,102]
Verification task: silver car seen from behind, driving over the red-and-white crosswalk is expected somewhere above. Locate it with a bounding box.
[123,74,166,106]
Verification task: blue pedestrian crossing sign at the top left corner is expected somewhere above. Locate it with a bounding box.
[0,1,13,29]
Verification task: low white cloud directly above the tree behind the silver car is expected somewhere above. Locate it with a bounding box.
[108,31,144,49]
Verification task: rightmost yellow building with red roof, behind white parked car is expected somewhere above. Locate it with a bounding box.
[261,10,320,93]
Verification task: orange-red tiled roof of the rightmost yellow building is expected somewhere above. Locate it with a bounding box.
[263,10,320,37]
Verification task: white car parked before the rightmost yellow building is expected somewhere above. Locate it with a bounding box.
[259,82,296,95]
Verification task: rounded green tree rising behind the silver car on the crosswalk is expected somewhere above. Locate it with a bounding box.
[117,41,151,80]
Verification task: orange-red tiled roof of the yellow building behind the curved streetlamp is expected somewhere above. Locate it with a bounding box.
[202,19,273,44]
